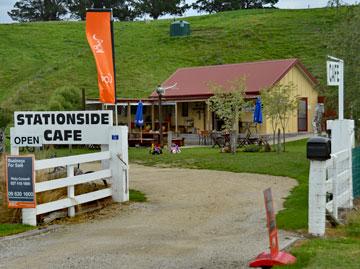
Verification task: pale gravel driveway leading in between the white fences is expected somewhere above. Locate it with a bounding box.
[0,165,296,269]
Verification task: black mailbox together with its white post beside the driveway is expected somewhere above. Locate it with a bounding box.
[306,137,331,236]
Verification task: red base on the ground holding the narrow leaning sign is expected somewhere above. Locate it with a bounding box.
[249,251,296,267]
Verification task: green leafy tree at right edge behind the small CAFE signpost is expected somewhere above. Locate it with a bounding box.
[324,5,360,138]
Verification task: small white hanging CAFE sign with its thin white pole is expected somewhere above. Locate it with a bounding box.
[327,56,344,120]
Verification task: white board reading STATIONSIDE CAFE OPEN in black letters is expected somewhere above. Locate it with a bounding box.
[10,110,113,147]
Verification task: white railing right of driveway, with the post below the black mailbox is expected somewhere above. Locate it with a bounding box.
[309,149,353,236]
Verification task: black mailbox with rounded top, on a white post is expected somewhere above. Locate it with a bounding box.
[306,136,331,161]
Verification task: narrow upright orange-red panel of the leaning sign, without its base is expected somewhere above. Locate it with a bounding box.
[264,188,279,257]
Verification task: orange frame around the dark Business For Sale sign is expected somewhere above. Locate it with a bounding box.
[4,154,37,208]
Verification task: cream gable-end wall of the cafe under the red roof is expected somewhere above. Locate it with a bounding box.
[266,66,318,134]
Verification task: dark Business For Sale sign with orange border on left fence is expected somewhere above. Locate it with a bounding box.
[5,155,36,208]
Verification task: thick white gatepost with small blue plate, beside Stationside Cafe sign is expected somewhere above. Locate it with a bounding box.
[109,126,129,202]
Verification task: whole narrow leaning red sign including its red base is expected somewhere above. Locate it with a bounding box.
[249,188,296,268]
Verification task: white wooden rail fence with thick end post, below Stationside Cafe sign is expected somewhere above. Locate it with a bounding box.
[12,126,129,226]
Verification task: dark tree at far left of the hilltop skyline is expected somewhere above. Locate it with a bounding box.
[8,0,67,22]
